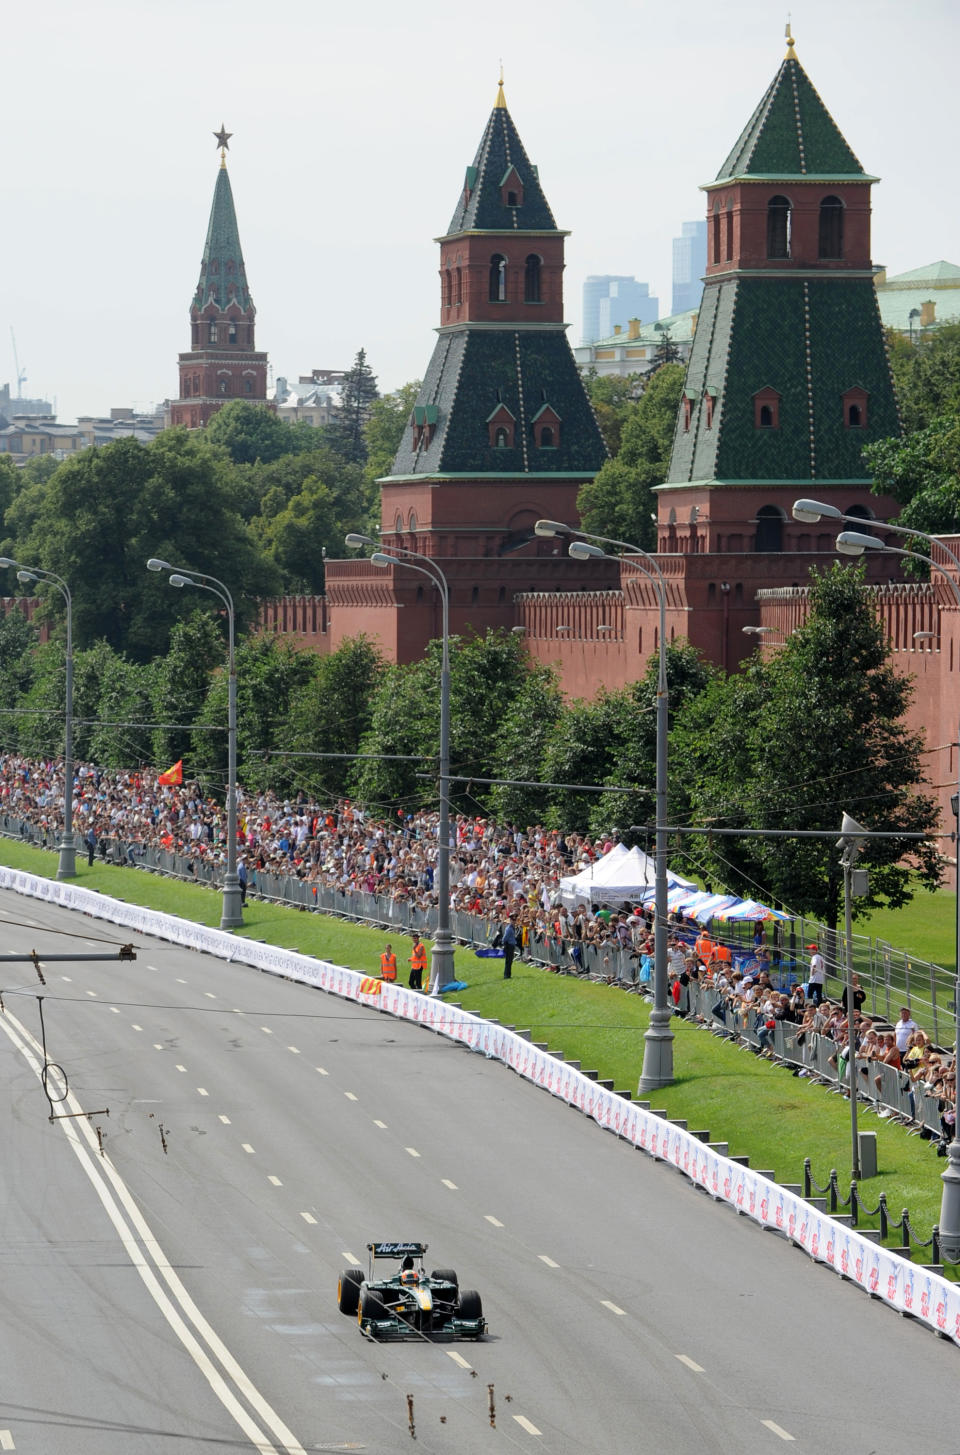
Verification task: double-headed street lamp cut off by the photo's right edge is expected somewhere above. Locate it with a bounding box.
[793,501,960,1263]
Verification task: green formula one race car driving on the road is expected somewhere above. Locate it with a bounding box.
[336,1243,487,1339]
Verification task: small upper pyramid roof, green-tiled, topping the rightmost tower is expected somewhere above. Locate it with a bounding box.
[716,57,865,182]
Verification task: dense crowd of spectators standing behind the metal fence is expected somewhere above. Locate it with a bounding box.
[0,754,956,1135]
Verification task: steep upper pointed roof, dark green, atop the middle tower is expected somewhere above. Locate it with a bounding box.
[447,106,557,234]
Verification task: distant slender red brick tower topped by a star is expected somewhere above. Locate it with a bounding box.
[170,127,266,429]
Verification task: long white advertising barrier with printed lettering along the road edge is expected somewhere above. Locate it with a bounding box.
[7,866,960,1343]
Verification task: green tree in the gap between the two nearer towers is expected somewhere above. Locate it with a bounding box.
[577,364,685,550]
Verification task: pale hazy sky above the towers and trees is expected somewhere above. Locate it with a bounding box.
[7,0,960,420]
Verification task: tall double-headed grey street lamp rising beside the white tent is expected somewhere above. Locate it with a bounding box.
[534,521,673,1093]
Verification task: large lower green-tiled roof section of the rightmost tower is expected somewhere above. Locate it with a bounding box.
[668,276,900,483]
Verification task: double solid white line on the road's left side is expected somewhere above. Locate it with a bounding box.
[0,1011,307,1455]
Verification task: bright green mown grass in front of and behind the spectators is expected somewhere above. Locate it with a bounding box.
[0,840,956,1262]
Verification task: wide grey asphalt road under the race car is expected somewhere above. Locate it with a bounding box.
[0,893,960,1455]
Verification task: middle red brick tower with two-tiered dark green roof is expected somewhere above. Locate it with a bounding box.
[326,84,608,661]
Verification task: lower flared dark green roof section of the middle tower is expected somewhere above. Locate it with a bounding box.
[391,329,607,477]
